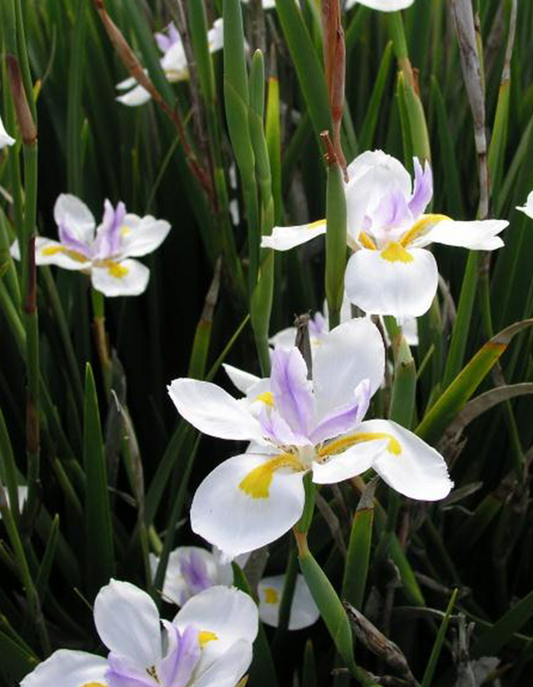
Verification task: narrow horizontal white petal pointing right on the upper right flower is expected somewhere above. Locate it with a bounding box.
[423,219,509,250]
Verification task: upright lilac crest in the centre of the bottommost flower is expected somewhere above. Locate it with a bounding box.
[159,623,200,687]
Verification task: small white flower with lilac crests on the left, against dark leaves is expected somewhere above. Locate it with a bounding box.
[11,194,170,296]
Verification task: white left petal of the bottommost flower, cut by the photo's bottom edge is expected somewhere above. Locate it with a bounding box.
[20,649,107,687]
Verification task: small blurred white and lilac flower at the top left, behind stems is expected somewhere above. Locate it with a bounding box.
[117,19,224,107]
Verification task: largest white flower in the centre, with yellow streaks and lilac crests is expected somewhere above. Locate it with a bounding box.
[169,318,452,557]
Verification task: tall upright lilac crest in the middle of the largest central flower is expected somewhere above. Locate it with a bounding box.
[270,348,315,436]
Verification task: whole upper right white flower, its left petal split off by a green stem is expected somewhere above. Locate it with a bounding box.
[262,150,509,319]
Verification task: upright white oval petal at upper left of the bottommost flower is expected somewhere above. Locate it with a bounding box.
[94,580,161,668]
